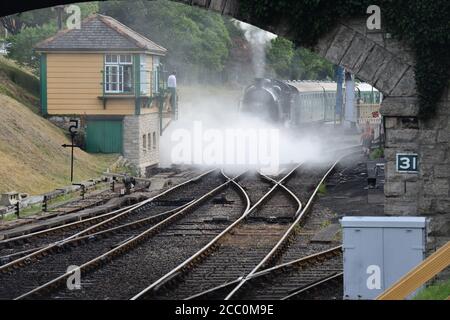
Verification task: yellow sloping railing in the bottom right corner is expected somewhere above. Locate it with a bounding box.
[377,241,450,300]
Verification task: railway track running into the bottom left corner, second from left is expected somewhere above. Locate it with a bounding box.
[0,170,229,299]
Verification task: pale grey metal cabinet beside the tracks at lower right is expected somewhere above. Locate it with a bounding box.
[341,217,426,299]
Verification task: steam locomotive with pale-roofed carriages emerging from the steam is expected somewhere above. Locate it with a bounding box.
[240,78,381,126]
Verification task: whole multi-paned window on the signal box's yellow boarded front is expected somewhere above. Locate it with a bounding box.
[105,54,133,93]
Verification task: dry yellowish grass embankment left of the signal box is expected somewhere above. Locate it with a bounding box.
[0,58,117,194]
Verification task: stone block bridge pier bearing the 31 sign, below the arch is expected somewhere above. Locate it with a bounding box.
[381,87,450,237]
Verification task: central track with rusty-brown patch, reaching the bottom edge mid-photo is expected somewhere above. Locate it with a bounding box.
[133,165,326,299]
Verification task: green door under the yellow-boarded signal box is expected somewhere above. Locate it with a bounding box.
[86,120,123,153]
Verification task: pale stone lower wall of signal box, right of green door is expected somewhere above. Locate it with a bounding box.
[123,113,160,176]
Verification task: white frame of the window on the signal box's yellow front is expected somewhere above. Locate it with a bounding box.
[104,53,134,93]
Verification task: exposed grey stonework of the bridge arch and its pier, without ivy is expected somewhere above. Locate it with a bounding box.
[174,0,450,240]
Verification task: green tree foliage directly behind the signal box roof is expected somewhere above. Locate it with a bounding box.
[100,0,232,77]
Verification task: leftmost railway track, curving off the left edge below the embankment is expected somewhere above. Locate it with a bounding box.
[0,171,218,264]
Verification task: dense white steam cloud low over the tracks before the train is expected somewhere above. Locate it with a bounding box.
[160,97,348,174]
